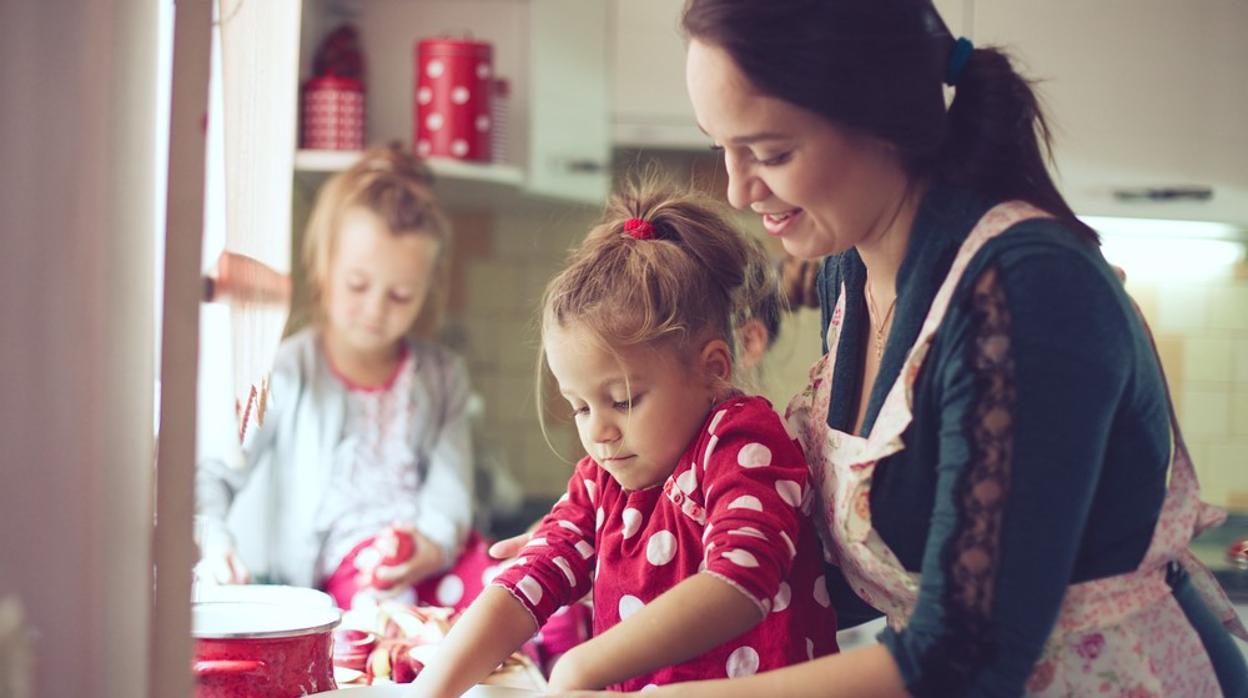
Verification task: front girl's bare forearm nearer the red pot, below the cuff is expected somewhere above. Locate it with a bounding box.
[412,586,538,698]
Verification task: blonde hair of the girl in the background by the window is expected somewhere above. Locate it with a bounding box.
[303,144,451,335]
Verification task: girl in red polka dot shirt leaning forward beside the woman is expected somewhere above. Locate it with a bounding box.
[418,184,836,697]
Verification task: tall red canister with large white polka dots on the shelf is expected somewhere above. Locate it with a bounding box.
[412,37,494,162]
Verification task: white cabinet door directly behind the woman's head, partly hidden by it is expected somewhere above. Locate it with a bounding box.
[609,0,970,149]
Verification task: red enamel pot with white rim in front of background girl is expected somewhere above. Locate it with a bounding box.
[191,602,339,698]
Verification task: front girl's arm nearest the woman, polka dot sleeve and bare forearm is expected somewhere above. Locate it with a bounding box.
[550,400,818,689]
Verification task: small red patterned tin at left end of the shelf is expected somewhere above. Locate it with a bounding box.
[300,75,364,150]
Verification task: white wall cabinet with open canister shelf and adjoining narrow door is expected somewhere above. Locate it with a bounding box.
[295,0,609,207]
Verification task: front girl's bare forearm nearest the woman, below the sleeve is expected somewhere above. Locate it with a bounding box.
[550,574,763,691]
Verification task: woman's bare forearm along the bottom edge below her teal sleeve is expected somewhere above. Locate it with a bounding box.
[557,644,910,698]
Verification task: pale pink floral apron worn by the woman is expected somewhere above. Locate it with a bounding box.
[787,201,1248,696]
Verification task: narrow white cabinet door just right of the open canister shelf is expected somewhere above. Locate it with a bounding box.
[529,0,610,202]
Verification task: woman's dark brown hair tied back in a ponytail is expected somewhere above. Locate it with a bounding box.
[681,0,1097,242]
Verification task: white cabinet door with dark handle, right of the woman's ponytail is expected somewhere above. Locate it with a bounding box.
[973,0,1248,222]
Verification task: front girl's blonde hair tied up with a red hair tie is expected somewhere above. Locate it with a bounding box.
[538,176,775,389]
